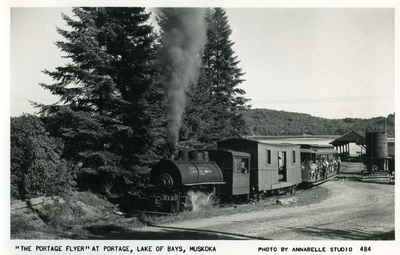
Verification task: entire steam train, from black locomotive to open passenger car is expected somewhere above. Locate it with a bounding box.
[130,138,338,212]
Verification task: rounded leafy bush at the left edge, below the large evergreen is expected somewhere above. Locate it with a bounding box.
[11,115,73,199]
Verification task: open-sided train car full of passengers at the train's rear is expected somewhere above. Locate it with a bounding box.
[300,144,340,185]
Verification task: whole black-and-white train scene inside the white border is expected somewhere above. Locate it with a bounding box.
[7,3,397,245]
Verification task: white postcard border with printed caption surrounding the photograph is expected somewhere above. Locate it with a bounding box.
[0,0,400,254]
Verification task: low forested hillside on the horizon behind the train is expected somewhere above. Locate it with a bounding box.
[244,109,394,137]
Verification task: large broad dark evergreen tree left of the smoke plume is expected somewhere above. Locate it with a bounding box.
[39,8,160,191]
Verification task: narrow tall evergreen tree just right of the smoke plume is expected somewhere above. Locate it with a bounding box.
[185,8,248,144]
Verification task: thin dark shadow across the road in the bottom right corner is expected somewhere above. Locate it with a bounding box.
[290,227,395,240]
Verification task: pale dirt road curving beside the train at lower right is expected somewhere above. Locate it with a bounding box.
[142,180,394,240]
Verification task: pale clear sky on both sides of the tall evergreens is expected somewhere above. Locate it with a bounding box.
[10,8,395,118]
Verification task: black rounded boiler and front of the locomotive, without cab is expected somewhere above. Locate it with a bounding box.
[146,150,225,211]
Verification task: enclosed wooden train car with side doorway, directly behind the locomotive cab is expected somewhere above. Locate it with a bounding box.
[218,138,301,193]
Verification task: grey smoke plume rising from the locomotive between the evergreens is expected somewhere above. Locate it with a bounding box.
[158,8,207,147]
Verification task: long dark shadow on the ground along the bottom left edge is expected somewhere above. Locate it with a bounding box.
[76,224,268,240]
